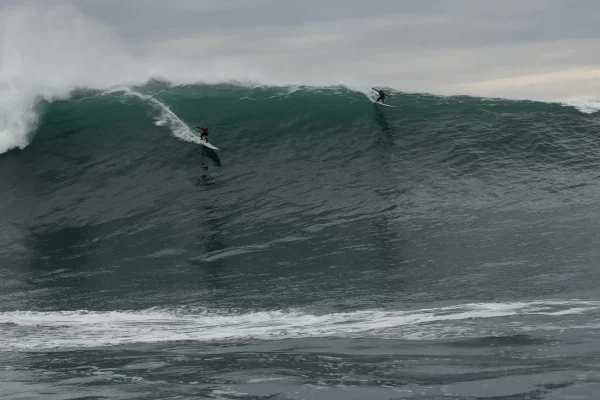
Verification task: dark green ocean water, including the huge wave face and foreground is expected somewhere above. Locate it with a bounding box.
[0,82,600,400]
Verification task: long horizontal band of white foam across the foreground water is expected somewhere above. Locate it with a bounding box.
[0,301,600,350]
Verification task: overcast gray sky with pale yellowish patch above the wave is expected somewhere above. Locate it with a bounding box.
[5,0,600,100]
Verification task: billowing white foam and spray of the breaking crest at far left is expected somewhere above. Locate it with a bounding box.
[0,3,147,153]
